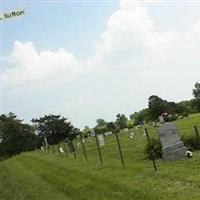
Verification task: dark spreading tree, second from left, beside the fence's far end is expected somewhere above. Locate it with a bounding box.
[32,114,77,144]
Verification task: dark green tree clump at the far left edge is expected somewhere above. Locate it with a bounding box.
[0,113,41,156]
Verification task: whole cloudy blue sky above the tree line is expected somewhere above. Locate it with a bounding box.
[0,0,200,128]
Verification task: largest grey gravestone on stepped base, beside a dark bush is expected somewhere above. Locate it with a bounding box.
[157,124,187,161]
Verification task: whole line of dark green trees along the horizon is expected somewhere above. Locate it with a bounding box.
[0,82,200,157]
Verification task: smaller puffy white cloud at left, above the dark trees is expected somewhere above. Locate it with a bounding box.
[4,41,81,87]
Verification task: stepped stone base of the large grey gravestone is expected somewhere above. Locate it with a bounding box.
[162,142,187,161]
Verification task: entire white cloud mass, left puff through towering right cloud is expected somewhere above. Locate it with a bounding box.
[4,0,200,128]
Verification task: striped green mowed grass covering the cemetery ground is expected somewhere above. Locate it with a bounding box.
[0,114,200,200]
